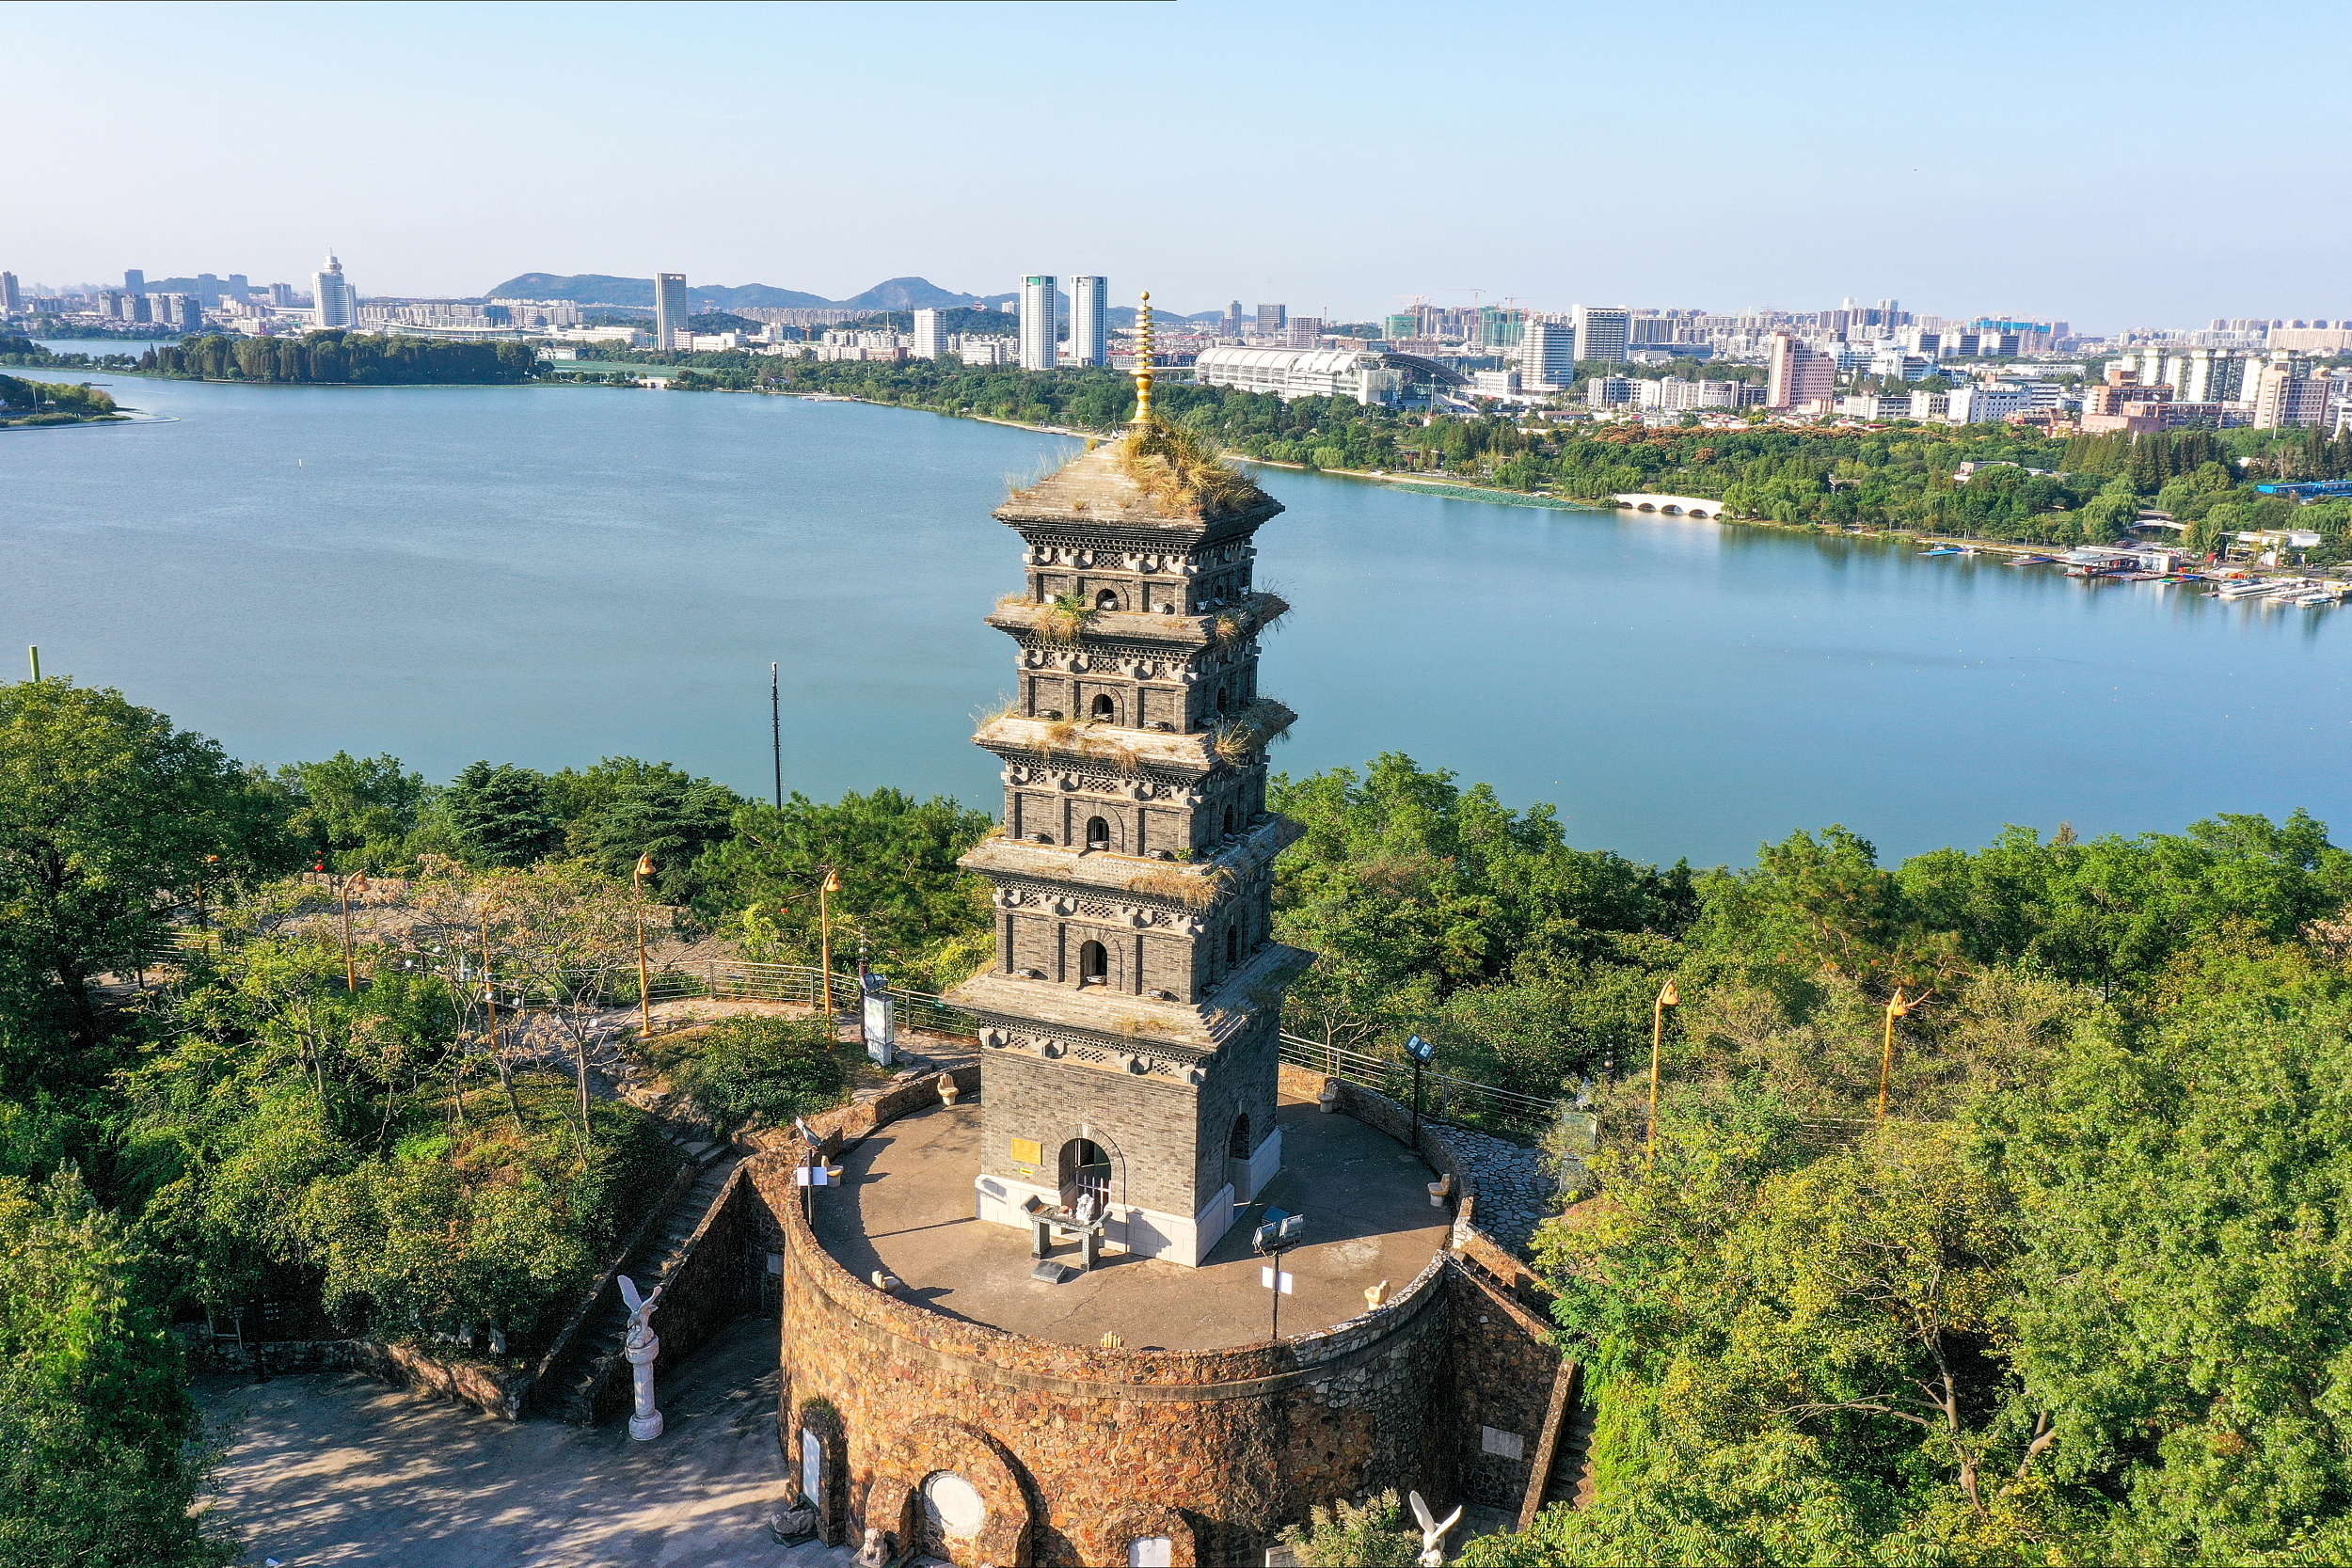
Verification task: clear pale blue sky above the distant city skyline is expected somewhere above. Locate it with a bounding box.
[18,0,2352,329]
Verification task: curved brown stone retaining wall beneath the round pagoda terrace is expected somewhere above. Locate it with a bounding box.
[746,1159,1458,1568]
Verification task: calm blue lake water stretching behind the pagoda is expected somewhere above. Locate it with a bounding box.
[0,361,2352,863]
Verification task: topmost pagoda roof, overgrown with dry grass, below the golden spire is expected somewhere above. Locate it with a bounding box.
[995,425,1282,536]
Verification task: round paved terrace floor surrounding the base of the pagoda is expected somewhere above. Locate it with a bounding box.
[812,1096,1452,1350]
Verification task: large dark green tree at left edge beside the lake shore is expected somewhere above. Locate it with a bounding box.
[0,679,294,1062]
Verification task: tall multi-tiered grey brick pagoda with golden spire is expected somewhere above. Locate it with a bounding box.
[950,293,1312,1267]
